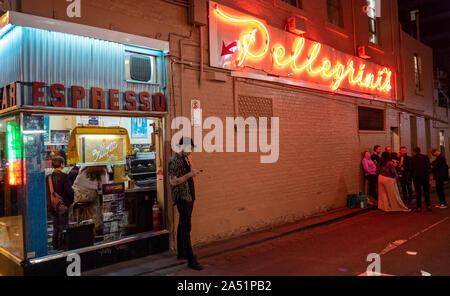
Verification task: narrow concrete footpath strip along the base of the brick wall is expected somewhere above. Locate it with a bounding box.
[82,206,372,276]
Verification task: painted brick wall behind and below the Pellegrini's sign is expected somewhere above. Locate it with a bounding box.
[13,0,450,246]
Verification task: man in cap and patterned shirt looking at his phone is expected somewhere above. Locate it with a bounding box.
[168,137,203,270]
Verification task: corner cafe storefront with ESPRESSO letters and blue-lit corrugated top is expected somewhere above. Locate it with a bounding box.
[0,12,169,275]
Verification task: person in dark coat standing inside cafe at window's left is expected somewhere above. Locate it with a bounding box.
[46,156,74,250]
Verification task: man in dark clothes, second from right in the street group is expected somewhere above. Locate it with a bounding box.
[411,147,431,213]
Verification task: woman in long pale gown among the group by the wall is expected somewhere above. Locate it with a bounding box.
[378,152,411,212]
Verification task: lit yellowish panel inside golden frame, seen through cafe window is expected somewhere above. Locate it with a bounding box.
[77,135,126,165]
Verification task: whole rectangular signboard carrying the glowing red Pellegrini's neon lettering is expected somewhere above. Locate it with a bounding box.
[211,4,392,97]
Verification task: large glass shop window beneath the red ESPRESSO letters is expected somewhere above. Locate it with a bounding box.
[23,114,164,254]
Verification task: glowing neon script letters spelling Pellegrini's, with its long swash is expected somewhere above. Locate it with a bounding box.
[213,4,392,94]
